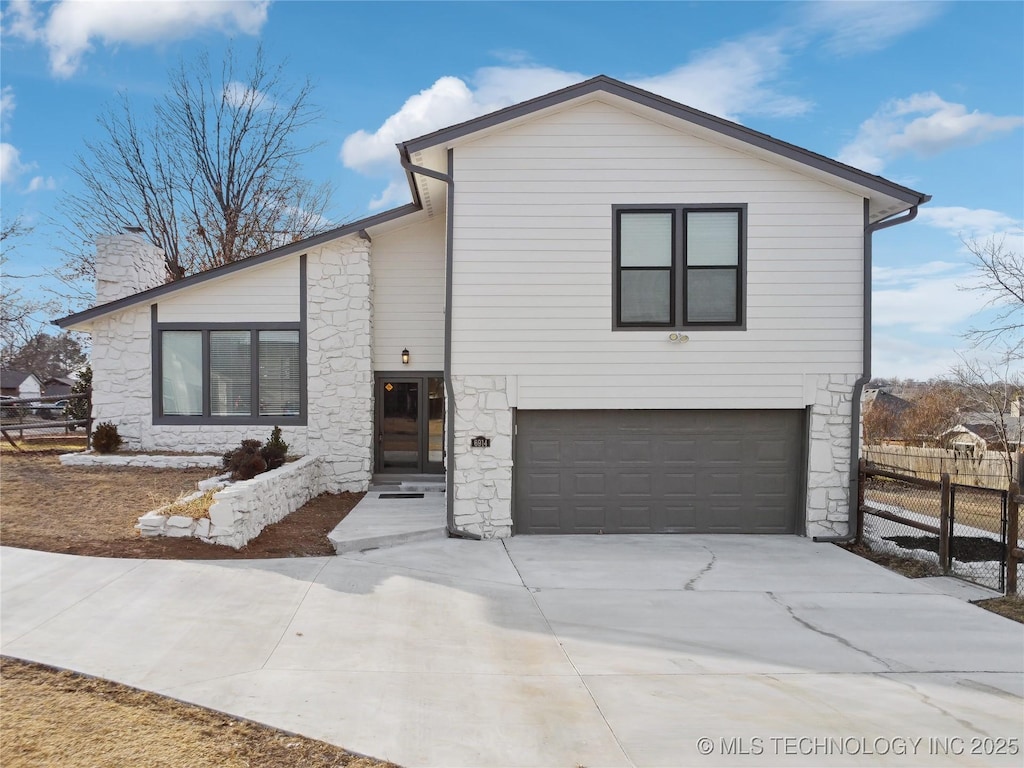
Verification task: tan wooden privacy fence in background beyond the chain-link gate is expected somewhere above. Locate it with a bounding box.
[861,445,1014,490]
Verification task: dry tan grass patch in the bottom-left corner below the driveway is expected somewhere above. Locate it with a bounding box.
[0,658,395,768]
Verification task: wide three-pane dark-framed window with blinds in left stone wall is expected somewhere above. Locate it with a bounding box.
[154,326,305,424]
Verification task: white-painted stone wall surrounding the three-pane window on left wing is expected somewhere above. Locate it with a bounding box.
[83,236,374,493]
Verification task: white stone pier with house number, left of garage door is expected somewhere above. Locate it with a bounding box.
[452,376,512,539]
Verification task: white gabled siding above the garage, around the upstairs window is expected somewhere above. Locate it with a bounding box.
[452,101,863,409]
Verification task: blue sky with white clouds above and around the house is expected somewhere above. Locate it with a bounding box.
[0,0,1024,378]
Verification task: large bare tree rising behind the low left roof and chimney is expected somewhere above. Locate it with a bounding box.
[60,49,331,281]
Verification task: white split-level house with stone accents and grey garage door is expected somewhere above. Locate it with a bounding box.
[58,77,929,537]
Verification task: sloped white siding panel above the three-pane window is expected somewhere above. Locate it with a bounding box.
[157,255,299,323]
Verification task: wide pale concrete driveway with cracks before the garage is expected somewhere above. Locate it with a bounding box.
[0,536,1024,768]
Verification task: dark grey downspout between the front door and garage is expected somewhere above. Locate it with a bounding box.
[398,144,482,541]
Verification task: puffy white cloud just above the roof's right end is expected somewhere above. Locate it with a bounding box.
[839,93,1024,173]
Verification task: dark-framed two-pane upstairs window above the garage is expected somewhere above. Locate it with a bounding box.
[612,206,745,329]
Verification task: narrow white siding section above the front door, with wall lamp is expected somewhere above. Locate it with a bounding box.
[372,214,444,371]
